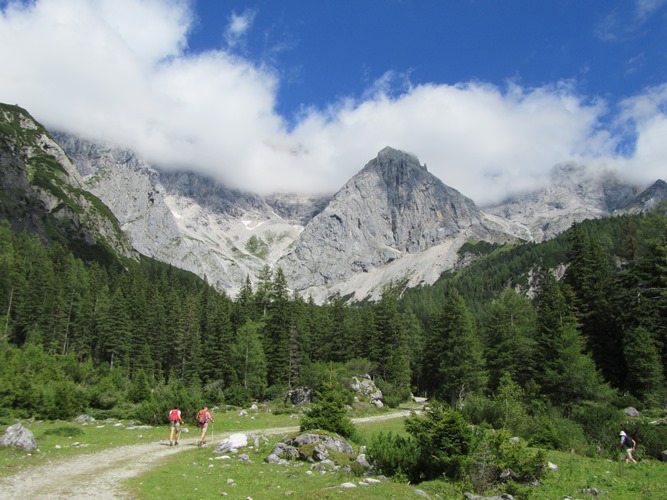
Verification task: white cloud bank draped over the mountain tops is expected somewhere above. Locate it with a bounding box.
[0,0,665,204]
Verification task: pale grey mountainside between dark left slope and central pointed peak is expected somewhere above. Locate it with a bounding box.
[55,134,322,296]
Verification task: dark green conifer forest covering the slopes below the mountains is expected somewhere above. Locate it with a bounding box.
[0,206,667,458]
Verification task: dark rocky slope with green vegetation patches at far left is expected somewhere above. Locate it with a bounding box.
[0,104,137,260]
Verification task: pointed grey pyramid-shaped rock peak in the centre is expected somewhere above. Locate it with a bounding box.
[277,147,509,299]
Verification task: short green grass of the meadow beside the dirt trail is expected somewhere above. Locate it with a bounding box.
[0,408,667,500]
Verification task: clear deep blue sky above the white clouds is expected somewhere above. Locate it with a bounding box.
[190,0,667,120]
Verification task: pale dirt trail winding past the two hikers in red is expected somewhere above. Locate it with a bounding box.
[0,410,420,500]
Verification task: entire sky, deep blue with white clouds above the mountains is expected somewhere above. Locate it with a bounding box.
[0,0,667,206]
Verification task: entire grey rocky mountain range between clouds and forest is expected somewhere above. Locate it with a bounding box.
[0,102,667,302]
